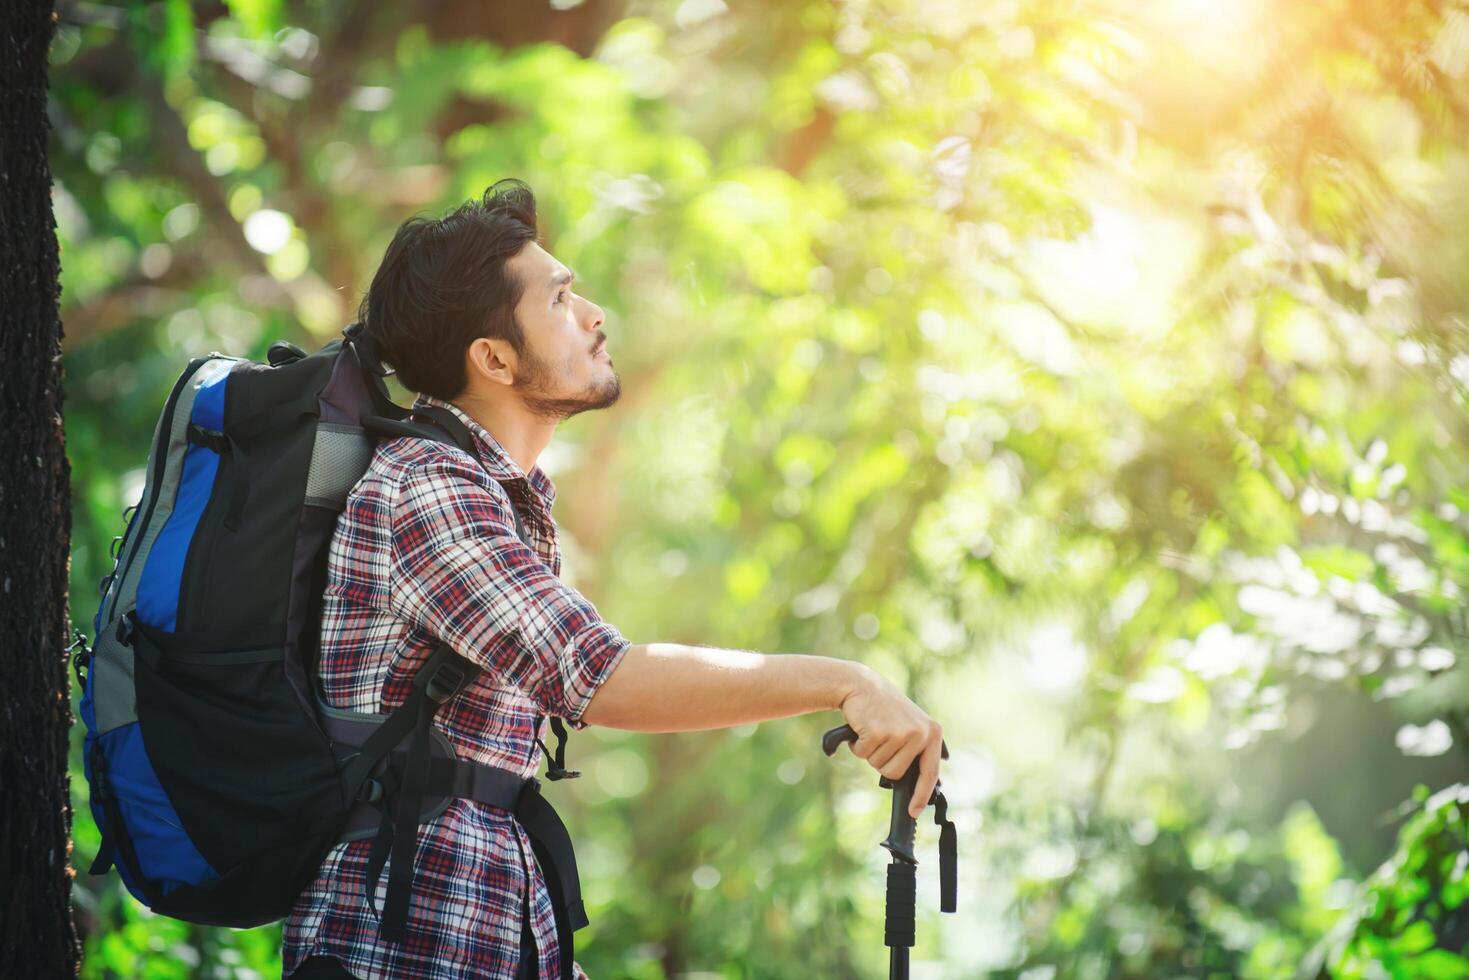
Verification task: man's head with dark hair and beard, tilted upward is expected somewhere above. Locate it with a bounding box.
[367,179,621,422]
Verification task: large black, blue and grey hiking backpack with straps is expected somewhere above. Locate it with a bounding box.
[75,323,586,977]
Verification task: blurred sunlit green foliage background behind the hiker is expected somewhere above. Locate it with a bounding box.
[50,0,1469,980]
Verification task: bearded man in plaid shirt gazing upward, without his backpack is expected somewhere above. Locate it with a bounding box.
[284,181,940,980]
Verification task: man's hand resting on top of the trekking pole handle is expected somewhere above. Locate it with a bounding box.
[842,670,943,818]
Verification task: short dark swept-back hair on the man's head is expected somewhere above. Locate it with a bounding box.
[357,178,538,400]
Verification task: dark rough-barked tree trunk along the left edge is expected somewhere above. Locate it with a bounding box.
[0,0,79,977]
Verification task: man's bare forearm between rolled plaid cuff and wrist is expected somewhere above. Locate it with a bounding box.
[582,644,870,732]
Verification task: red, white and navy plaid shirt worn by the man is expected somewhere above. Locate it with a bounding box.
[284,397,630,980]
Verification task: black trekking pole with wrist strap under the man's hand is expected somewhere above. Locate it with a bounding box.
[821,724,959,980]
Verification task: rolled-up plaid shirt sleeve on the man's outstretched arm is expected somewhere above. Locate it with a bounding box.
[388,458,632,729]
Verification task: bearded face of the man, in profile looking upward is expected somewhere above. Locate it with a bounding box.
[505,242,621,422]
